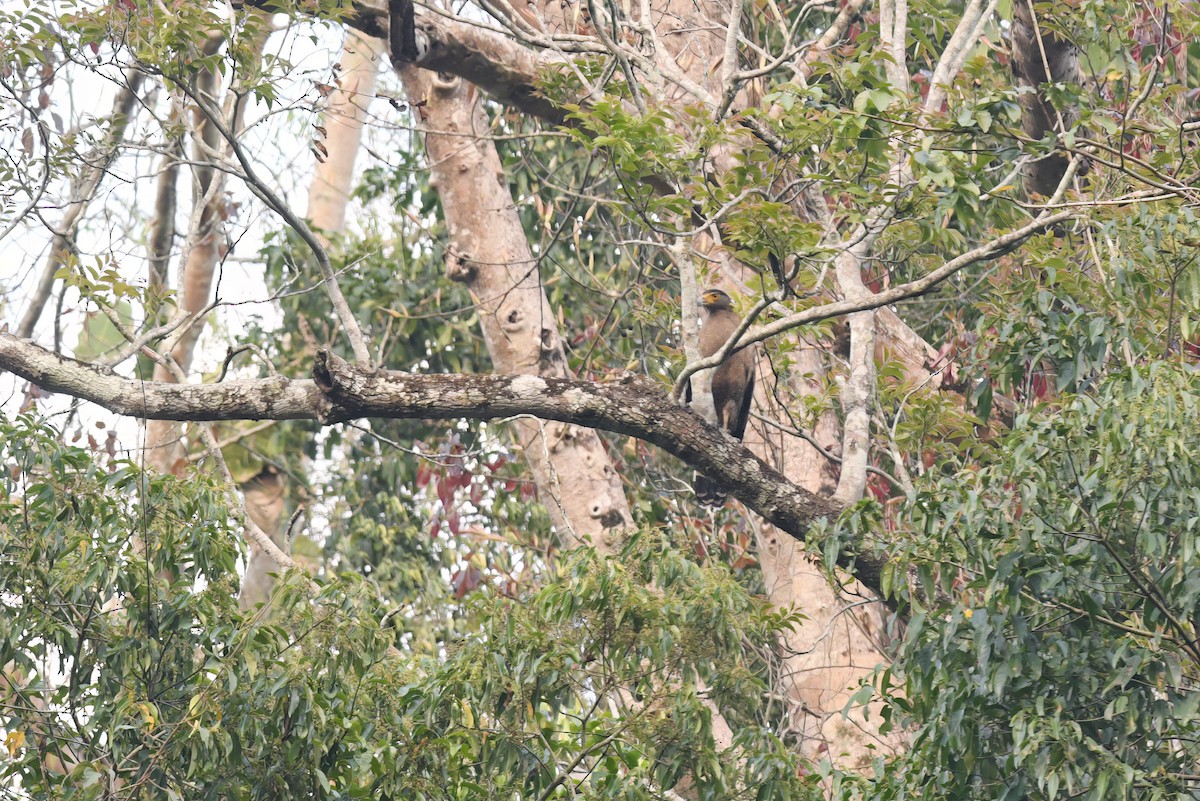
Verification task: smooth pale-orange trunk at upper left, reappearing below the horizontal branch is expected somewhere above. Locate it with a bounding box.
[238,30,384,609]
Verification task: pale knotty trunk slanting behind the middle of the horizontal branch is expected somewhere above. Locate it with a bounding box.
[397,66,632,550]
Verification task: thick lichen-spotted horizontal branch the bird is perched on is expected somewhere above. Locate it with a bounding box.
[0,332,884,592]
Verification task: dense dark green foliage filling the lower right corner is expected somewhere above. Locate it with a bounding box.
[858,362,1200,800]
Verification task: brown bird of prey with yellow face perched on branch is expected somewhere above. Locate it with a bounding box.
[688,289,755,506]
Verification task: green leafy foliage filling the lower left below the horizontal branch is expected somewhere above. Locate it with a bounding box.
[0,417,814,799]
